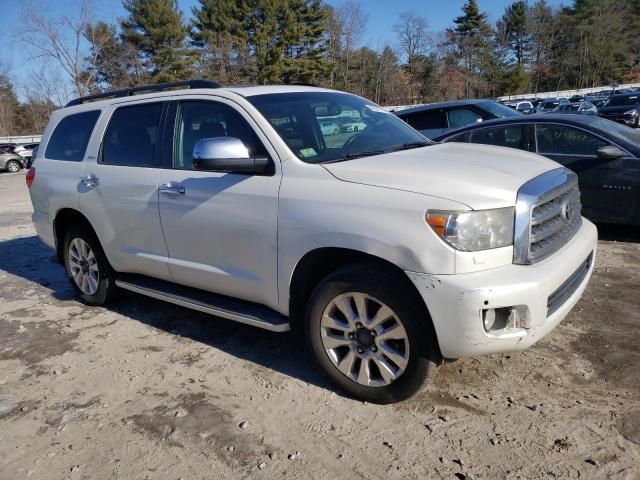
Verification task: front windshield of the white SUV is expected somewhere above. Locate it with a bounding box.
[248,92,431,163]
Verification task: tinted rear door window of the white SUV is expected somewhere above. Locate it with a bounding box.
[102,103,162,167]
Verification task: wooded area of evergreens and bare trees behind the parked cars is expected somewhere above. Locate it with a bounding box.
[0,0,640,135]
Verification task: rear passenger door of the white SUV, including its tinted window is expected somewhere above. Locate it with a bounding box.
[78,101,170,280]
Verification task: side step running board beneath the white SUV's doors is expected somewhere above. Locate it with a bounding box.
[116,274,290,332]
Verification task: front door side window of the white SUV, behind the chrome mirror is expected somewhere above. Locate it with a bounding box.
[173,101,266,169]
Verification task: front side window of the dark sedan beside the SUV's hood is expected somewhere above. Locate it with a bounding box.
[536,125,608,157]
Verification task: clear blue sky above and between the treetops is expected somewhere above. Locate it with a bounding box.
[0,0,571,98]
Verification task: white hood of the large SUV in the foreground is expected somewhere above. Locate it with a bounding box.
[324,143,560,210]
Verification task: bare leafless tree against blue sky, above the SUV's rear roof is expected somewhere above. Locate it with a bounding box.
[18,0,104,96]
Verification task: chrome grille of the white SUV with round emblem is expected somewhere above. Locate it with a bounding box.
[513,168,582,264]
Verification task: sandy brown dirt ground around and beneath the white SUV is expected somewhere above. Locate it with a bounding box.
[0,173,640,480]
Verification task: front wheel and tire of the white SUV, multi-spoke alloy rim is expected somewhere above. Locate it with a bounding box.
[305,264,436,404]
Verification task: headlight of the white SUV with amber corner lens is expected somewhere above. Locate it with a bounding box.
[426,207,515,252]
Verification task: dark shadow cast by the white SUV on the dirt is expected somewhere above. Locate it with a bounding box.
[0,232,332,394]
